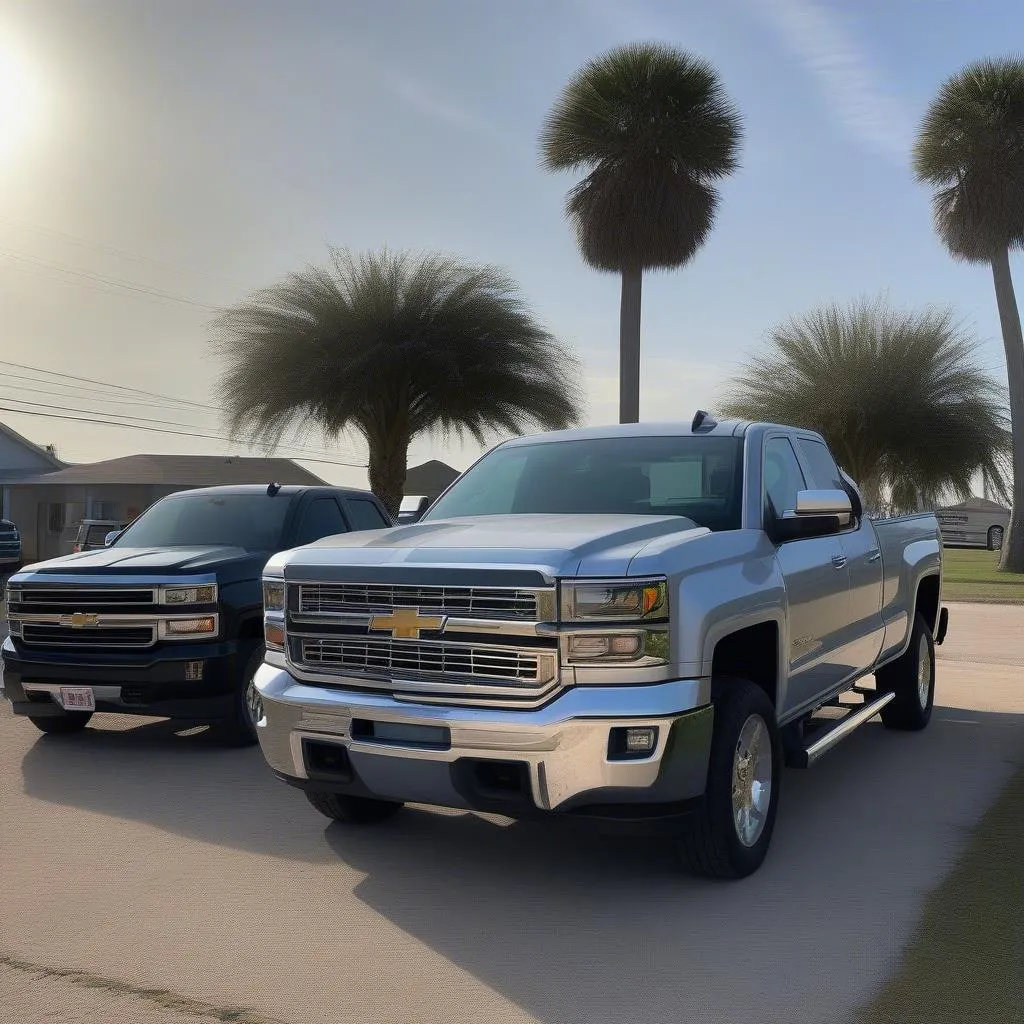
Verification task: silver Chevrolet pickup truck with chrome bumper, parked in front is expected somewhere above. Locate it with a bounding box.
[254,413,948,878]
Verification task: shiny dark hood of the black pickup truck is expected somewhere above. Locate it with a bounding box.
[24,545,271,583]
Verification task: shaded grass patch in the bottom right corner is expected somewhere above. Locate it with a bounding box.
[858,769,1024,1024]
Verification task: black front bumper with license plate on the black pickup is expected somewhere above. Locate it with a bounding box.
[3,638,249,721]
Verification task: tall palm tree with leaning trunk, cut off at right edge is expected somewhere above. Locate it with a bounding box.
[913,57,1024,572]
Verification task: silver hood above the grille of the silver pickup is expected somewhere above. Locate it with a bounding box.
[268,515,709,579]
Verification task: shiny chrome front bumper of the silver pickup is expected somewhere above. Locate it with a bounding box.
[256,665,713,816]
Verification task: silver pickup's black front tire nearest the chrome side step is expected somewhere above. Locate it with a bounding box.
[678,679,782,879]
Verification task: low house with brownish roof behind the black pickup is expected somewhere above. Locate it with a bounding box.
[0,450,325,562]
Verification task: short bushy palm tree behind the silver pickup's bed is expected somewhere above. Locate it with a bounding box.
[723,299,1012,512]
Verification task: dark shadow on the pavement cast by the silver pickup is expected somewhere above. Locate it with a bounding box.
[326,710,1024,1024]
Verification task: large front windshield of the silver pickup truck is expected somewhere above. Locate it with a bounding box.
[423,435,743,530]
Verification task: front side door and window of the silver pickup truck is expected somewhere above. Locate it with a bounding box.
[763,434,851,715]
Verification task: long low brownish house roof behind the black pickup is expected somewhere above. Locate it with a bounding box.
[11,455,325,487]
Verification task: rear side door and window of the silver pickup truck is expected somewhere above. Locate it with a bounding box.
[797,437,885,672]
